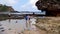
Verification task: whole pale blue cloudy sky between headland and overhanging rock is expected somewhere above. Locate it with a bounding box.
[0,0,40,11]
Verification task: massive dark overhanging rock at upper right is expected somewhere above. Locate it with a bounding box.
[36,0,60,16]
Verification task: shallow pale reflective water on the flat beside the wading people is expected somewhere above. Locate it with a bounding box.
[0,18,36,34]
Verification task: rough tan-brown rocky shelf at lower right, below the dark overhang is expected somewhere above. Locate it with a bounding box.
[36,17,60,34]
